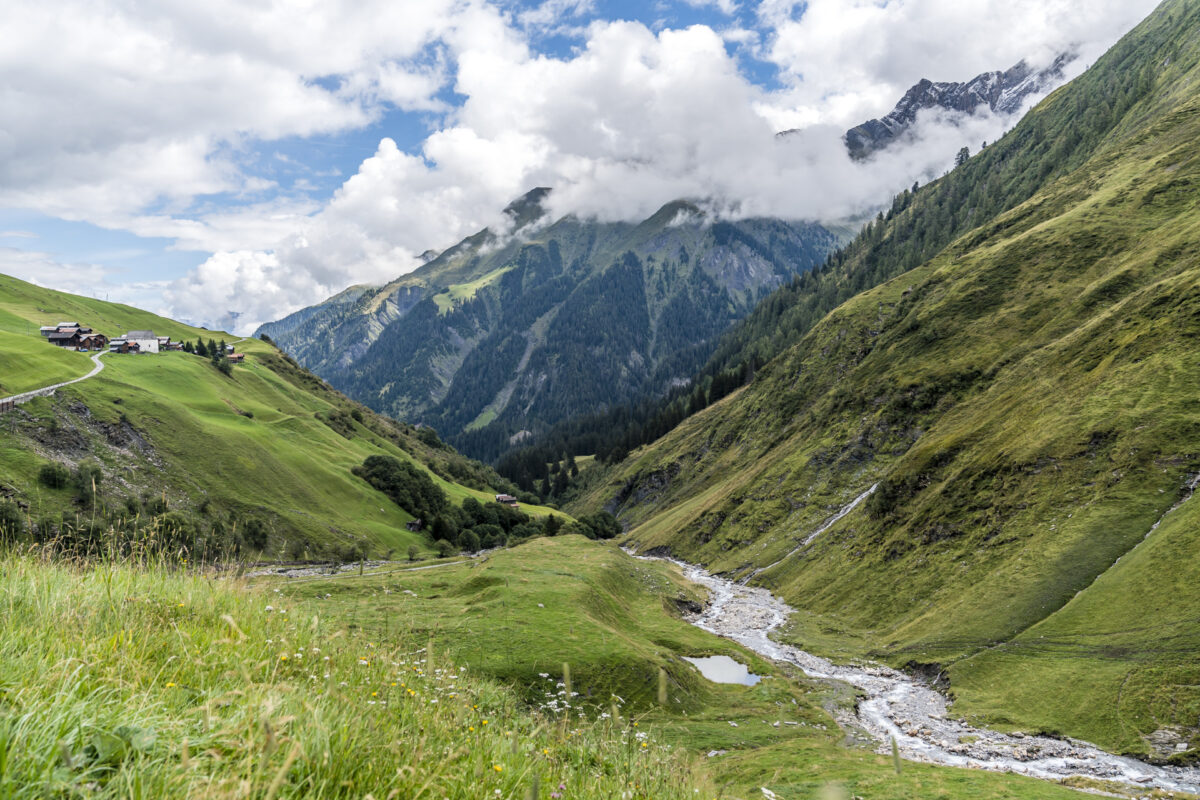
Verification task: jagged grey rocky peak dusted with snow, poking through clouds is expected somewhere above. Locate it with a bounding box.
[844,54,1074,158]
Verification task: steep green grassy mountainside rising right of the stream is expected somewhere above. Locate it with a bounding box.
[568,1,1200,753]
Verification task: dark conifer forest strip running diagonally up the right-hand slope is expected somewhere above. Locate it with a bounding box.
[496,34,1154,491]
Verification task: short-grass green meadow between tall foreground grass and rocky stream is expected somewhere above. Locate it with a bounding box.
[272,536,1099,800]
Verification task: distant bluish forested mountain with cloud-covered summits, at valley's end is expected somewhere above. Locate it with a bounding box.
[262,190,836,458]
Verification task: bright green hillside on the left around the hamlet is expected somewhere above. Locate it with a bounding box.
[0,276,566,558]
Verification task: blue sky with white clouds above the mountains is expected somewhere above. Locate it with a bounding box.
[0,0,1157,333]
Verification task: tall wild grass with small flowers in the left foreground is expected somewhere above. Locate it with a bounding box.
[0,553,702,800]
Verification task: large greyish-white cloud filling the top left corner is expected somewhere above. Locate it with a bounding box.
[0,0,462,221]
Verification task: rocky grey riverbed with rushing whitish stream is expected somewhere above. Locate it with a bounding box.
[652,554,1200,794]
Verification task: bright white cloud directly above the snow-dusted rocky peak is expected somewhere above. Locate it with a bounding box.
[757,0,1158,126]
